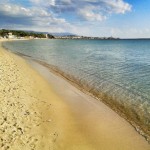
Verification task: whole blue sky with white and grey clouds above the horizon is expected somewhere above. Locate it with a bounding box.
[0,0,150,38]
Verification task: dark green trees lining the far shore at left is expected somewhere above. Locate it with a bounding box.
[0,29,54,39]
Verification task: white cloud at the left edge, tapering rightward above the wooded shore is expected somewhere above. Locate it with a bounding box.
[0,3,71,27]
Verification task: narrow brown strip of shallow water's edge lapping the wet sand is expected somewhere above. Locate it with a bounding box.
[12,52,150,144]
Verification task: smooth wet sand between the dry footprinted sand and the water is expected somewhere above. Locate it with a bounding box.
[28,59,150,150]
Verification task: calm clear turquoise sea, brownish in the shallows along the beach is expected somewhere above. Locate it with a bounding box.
[3,39,150,141]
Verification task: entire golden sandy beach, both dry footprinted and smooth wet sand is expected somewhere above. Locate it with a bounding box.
[0,39,150,150]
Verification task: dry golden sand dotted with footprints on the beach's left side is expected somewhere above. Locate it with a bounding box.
[0,40,79,150]
